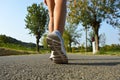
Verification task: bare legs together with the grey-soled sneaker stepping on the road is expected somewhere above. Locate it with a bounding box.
[47,0,68,64]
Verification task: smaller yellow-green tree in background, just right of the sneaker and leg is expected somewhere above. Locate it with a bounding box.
[63,23,81,52]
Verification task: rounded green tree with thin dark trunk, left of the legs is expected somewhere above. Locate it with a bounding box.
[25,3,48,52]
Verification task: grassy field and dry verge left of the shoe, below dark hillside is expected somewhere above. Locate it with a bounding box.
[0,43,48,56]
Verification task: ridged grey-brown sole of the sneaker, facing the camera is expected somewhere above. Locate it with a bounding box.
[47,35,68,64]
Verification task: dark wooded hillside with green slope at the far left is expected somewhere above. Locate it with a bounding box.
[0,35,36,49]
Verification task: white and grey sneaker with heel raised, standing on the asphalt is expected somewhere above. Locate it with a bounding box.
[47,30,68,64]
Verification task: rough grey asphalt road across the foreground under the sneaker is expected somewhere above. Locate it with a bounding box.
[0,54,120,80]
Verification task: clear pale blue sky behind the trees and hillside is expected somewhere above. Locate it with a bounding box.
[0,0,120,45]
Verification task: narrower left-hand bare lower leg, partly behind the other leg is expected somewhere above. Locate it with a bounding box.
[46,0,55,33]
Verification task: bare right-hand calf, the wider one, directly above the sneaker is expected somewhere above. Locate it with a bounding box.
[54,0,66,34]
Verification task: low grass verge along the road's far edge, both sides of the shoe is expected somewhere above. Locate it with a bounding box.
[0,47,120,56]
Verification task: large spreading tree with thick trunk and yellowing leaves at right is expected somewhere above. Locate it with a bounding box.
[68,0,120,52]
